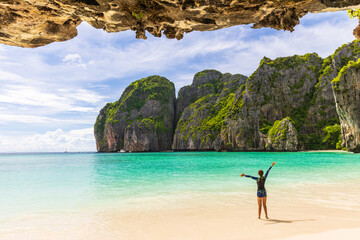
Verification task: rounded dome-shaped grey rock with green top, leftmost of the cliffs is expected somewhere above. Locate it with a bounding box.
[94,76,175,152]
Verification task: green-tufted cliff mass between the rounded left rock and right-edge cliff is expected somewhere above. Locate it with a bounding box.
[173,51,344,151]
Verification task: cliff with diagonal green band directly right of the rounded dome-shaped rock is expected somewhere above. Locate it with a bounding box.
[173,70,247,150]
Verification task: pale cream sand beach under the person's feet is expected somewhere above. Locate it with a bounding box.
[0,183,360,240]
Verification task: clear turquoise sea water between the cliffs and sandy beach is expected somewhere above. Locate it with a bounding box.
[0,152,360,217]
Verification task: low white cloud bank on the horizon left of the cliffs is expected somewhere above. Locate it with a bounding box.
[0,128,95,152]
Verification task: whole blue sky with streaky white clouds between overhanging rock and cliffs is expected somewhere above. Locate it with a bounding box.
[0,12,357,152]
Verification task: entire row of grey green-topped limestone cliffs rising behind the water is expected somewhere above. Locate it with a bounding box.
[95,40,360,152]
